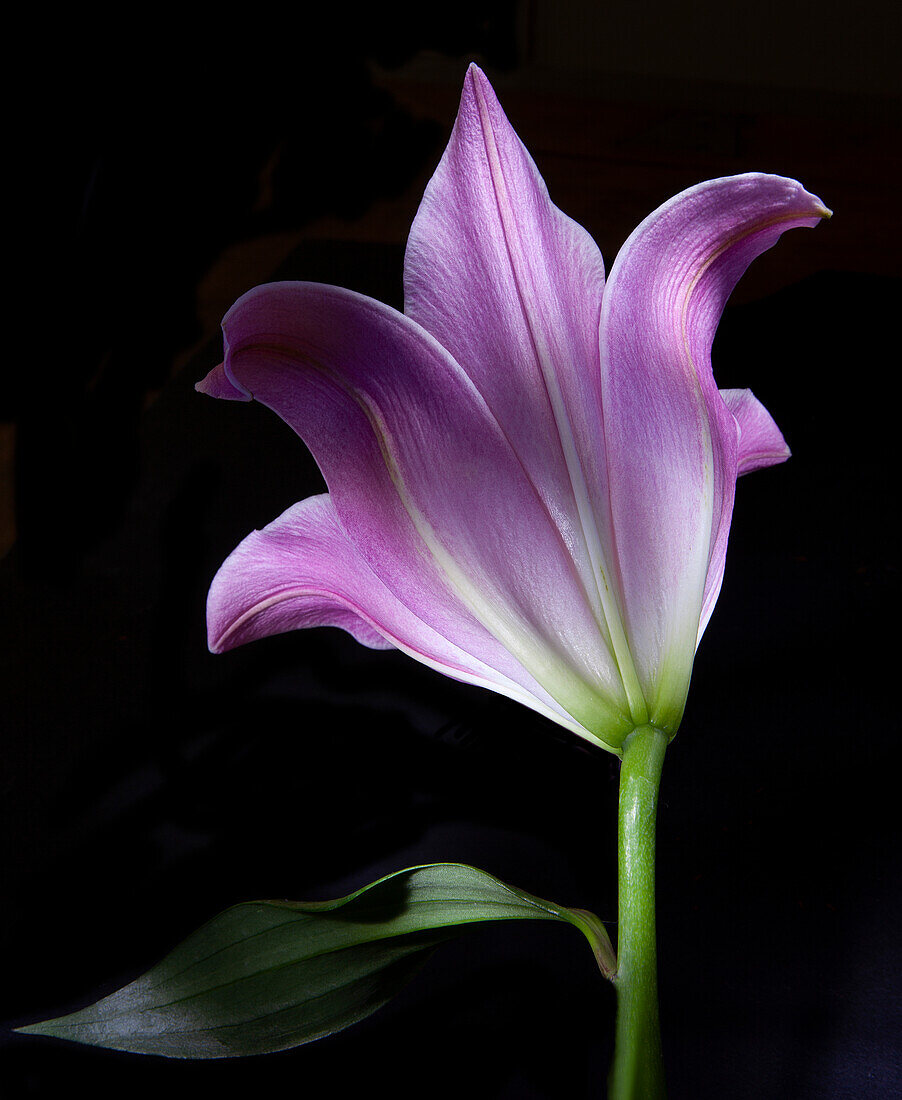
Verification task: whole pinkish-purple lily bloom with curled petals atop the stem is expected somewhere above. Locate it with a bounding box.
[197,65,829,754]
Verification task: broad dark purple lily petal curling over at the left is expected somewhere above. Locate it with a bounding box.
[201,283,633,747]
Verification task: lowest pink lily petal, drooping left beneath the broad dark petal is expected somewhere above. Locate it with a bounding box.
[207,494,584,735]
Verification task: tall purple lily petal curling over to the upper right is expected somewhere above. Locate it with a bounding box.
[600,174,829,729]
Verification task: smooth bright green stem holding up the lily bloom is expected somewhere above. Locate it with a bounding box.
[608,726,668,1100]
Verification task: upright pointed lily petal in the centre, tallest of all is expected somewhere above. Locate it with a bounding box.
[405,65,647,724]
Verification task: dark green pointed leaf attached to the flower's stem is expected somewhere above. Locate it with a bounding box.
[19,864,615,1058]
